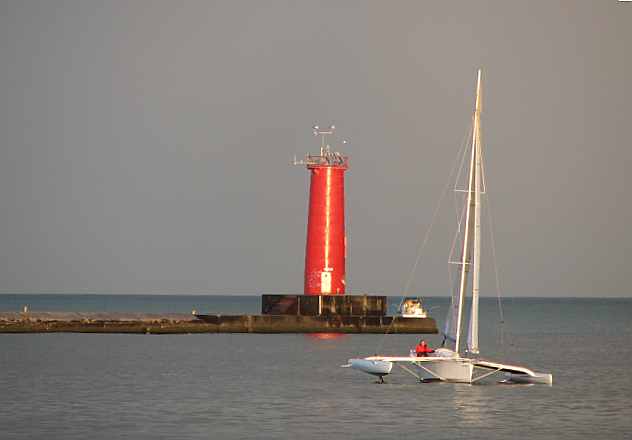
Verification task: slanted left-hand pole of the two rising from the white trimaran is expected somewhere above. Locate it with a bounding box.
[454,70,481,353]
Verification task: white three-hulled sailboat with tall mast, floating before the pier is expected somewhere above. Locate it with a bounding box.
[343,69,553,385]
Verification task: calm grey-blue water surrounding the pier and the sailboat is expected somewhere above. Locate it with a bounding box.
[0,295,632,440]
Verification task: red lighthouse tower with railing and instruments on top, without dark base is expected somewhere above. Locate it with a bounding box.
[294,125,348,295]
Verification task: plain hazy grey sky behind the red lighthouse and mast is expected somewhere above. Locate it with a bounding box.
[0,0,632,296]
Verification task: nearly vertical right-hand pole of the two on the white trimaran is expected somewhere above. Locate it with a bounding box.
[468,69,482,354]
